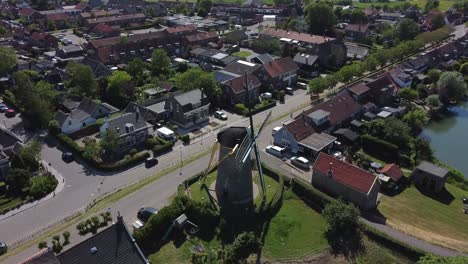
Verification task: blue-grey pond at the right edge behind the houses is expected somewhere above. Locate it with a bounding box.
[421,102,468,178]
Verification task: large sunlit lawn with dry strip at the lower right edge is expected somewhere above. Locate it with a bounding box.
[378,184,468,252]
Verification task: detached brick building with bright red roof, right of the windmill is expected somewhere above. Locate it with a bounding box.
[312,153,380,210]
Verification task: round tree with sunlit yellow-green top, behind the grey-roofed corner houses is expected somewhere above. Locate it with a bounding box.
[106,71,135,107]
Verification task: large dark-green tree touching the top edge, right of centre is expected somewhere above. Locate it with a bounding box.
[306,2,336,35]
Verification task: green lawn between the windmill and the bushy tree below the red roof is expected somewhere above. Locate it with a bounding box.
[263,190,328,259]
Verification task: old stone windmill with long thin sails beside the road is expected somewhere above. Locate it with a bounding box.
[210,73,271,208]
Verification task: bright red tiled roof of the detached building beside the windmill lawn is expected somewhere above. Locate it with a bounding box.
[312,152,376,194]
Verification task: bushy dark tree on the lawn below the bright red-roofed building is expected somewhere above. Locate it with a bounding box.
[322,200,361,250]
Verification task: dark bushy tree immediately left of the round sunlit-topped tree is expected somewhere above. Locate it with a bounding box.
[66,60,98,98]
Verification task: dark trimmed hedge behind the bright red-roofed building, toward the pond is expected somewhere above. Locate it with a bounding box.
[361,135,398,162]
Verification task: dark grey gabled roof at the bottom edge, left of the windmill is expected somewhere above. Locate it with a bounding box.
[57,220,148,264]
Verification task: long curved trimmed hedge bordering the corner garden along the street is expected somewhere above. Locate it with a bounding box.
[57,133,151,171]
